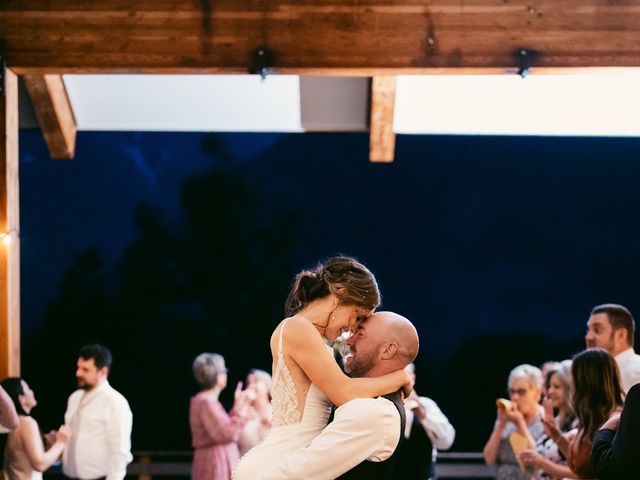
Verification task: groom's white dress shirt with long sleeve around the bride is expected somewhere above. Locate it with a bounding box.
[256,397,400,480]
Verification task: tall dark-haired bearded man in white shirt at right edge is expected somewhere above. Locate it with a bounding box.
[585,303,640,393]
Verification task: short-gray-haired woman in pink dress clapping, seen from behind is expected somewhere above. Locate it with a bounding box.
[189,353,249,480]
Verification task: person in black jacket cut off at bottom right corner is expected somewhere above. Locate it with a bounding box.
[591,384,640,480]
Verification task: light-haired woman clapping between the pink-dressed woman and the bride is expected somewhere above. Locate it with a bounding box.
[238,369,272,456]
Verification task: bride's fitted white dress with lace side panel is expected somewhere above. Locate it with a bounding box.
[233,320,331,480]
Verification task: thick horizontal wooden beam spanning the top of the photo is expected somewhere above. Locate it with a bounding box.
[0,0,640,76]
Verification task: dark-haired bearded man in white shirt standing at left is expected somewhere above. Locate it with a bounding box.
[62,344,133,480]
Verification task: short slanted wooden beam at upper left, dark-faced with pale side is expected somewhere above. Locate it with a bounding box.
[24,75,77,160]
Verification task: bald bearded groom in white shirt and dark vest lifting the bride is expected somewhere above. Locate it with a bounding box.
[260,312,418,480]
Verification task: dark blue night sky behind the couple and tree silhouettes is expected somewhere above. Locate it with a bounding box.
[15,131,640,450]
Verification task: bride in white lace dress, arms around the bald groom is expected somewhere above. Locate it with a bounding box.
[233,257,411,480]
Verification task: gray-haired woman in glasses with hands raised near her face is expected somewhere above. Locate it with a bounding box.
[483,364,544,480]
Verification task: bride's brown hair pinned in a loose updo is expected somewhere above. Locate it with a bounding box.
[285,256,380,317]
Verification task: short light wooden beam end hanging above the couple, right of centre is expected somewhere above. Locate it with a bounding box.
[369,76,396,163]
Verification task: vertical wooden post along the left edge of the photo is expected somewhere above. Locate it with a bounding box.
[0,61,20,378]
